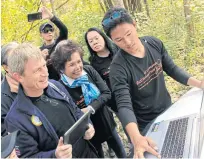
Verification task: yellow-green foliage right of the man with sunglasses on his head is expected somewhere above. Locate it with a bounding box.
[134,0,204,71]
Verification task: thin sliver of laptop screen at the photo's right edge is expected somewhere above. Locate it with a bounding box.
[199,90,204,154]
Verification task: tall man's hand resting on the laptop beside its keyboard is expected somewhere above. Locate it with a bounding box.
[134,135,161,158]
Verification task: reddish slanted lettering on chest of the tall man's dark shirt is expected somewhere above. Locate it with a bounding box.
[136,59,163,90]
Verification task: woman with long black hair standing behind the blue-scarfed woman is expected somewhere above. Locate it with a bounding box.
[85,28,119,102]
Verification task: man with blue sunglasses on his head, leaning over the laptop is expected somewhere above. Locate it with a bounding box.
[102,8,204,158]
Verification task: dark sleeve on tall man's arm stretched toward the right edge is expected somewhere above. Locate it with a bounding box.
[153,38,191,85]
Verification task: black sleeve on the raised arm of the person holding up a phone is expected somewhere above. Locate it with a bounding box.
[50,16,68,44]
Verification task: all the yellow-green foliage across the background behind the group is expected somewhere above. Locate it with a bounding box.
[1,0,204,68]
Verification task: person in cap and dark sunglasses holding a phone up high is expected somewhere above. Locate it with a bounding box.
[39,7,68,80]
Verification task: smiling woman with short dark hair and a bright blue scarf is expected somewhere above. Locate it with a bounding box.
[51,40,126,158]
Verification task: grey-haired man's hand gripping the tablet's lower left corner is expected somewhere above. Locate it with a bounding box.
[55,137,72,158]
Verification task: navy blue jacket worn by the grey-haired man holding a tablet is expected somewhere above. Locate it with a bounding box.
[5,80,86,158]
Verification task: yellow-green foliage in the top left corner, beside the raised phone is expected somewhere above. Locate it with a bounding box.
[1,0,41,44]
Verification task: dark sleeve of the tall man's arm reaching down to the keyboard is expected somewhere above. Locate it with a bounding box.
[110,63,137,128]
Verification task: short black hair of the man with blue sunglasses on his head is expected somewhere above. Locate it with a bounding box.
[102,7,133,38]
